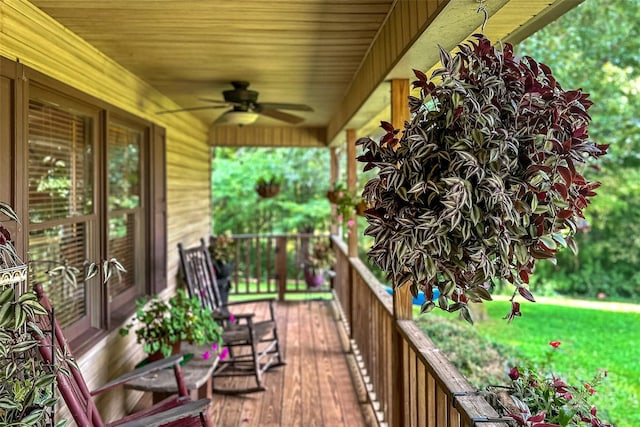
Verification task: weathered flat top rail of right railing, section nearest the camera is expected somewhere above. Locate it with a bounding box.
[397,320,511,427]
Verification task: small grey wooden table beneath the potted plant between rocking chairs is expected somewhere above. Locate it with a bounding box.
[125,343,219,404]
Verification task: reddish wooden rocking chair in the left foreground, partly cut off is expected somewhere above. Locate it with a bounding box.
[34,284,212,427]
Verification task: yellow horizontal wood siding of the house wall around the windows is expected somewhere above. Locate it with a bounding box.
[0,0,211,419]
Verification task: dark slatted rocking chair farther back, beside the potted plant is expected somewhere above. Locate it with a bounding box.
[178,239,285,394]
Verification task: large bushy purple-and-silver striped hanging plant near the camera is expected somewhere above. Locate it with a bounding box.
[357,35,607,322]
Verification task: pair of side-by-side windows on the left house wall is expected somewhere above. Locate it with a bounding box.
[27,87,166,340]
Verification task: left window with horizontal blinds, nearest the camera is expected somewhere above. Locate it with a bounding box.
[28,100,97,329]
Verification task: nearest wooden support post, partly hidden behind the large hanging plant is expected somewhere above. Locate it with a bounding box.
[391,79,413,426]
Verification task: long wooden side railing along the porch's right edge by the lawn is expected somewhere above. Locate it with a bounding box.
[333,239,510,427]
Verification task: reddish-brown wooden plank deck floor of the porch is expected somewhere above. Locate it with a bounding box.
[211,300,366,427]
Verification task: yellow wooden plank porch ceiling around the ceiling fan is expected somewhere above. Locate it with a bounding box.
[31,0,581,143]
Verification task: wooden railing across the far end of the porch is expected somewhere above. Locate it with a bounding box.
[225,234,331,300]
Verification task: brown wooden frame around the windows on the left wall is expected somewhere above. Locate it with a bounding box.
[0,56,167,354]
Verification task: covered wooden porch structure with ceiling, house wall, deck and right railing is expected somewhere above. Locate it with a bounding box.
[0,0,580,427]
